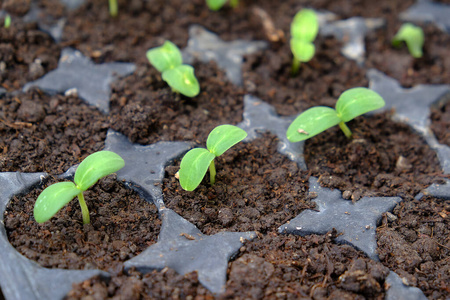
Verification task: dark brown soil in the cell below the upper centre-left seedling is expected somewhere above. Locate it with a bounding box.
[109,63,244,145]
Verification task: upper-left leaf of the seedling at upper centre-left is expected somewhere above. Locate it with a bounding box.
[147,41,183,73]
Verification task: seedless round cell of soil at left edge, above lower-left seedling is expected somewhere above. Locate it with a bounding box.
[0,91,108,174]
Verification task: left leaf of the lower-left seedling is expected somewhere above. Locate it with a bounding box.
[33,182,82,223]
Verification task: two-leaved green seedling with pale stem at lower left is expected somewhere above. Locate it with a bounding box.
[34,151,125,224]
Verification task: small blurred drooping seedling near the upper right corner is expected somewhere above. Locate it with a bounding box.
[392,23,425,58]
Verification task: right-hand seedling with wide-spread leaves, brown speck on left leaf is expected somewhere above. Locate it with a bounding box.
[286,87,385,142]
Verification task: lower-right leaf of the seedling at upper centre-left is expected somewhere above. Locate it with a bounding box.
[162,65,200,97]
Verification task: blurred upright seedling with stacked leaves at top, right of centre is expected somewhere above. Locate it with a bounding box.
[291,8,319,75]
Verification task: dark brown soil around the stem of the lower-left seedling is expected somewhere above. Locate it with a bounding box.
[5,175,161,270]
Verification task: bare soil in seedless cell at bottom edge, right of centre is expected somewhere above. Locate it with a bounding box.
[223,232,389,299]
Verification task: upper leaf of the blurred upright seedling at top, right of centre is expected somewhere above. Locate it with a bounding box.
[291,8,319,42]
